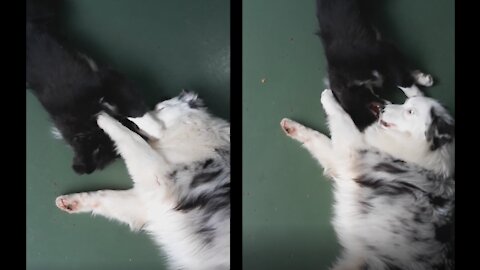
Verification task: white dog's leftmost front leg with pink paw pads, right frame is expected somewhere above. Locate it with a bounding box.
[280,118,335,176]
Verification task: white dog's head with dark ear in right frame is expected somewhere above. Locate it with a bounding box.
[378,96,455,151]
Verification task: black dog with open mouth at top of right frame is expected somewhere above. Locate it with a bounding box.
[317,0,433,130]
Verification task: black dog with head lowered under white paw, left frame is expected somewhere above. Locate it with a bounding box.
[26,0,148,174]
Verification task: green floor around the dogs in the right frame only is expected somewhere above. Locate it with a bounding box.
[242,0,455,270]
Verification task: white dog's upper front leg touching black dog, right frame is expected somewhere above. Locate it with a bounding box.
[321,89,362,151]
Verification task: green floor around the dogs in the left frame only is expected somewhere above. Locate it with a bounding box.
[26,0,230,270]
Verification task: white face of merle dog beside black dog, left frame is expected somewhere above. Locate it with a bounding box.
[155,91,204,128]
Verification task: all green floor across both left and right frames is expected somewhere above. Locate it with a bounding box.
[26,0,455,270]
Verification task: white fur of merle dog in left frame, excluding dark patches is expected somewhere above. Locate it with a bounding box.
[56,93,230,270]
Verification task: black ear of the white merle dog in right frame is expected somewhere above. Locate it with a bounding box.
[425,108,455,151]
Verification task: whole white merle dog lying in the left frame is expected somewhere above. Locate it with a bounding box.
[56,92,230,270]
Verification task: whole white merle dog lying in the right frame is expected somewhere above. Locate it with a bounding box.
[281,85,455,270]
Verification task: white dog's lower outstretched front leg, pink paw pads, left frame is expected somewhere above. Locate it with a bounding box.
[55,189,147,230]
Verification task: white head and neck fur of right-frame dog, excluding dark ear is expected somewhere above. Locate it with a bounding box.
[364,87,455,177]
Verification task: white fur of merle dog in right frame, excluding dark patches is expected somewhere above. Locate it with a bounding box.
[281,89,455,270]
